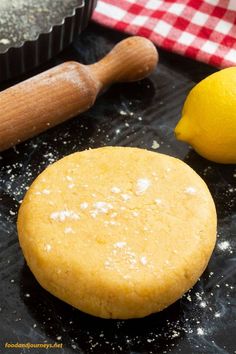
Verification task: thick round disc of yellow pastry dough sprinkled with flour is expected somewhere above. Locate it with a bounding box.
[18,147,216,319]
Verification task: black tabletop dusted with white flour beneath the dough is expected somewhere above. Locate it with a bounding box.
[0,25,236,354]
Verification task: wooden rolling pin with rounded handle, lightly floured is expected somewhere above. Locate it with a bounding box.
[0,37,158,151]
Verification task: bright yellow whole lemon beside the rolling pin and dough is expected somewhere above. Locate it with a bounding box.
[175,67,236,163]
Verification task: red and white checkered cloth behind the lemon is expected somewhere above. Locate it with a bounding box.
[93,0,236,68]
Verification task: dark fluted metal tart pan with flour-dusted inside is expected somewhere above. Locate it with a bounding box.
[0,0,97,81]
